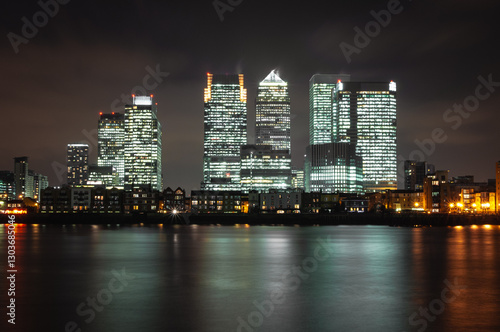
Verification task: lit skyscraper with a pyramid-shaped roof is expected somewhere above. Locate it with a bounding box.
[255,70,290,151]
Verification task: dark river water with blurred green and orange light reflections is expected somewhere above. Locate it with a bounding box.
[0,225,500,331]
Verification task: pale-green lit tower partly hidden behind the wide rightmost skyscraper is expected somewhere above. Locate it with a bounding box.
[309,74,351,145]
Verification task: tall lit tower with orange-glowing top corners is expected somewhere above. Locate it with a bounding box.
[202,73,247,191]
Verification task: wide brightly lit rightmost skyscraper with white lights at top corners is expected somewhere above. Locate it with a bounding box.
[332,81,397,192]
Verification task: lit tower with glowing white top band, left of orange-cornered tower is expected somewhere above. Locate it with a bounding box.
[124,95,163,191]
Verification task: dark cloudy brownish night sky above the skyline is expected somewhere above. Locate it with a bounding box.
[0,0,500,191]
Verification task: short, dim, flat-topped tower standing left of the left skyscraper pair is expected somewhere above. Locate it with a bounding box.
[67,144,89,186]
